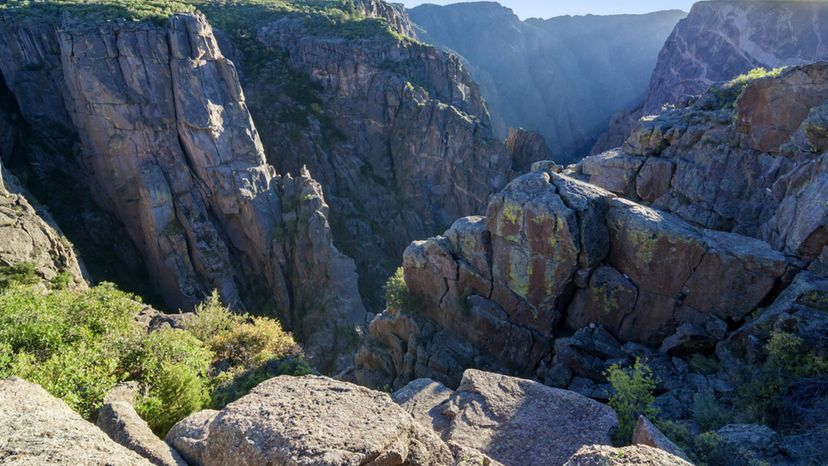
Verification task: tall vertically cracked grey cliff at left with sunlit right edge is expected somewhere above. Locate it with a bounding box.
[0,14,365,370]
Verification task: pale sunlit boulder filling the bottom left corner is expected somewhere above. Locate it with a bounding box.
[0,378,152,466]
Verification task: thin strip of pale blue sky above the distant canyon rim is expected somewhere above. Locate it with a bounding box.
[404,0,695,19]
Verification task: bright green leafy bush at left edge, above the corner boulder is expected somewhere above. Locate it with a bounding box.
[0,284,141,418]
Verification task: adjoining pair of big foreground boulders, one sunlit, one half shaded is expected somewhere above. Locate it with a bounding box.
[167,370,618,466]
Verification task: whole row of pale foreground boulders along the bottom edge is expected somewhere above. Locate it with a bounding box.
[0,370,687,466]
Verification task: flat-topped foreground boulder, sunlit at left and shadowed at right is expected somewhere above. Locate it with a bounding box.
[446,369,618,466]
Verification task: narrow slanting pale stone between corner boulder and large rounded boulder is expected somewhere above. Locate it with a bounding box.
[97,401,187,466]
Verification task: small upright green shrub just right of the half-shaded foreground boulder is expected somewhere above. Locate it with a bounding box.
[606,359,658,445]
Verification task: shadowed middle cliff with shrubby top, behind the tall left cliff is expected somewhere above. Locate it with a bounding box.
[200,2,511,310]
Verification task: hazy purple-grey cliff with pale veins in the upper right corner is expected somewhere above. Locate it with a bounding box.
[593,0,828,154]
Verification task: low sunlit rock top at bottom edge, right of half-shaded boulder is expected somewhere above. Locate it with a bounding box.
[564,445,690,466]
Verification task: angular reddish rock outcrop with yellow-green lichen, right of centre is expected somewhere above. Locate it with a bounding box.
[357,168,788,387]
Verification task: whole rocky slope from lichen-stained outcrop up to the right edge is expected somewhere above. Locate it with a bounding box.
[357,62,828,387]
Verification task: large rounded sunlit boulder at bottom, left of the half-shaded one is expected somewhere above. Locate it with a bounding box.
[167,376,453,466]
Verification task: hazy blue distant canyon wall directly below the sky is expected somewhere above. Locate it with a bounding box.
[409,2,685,162]
